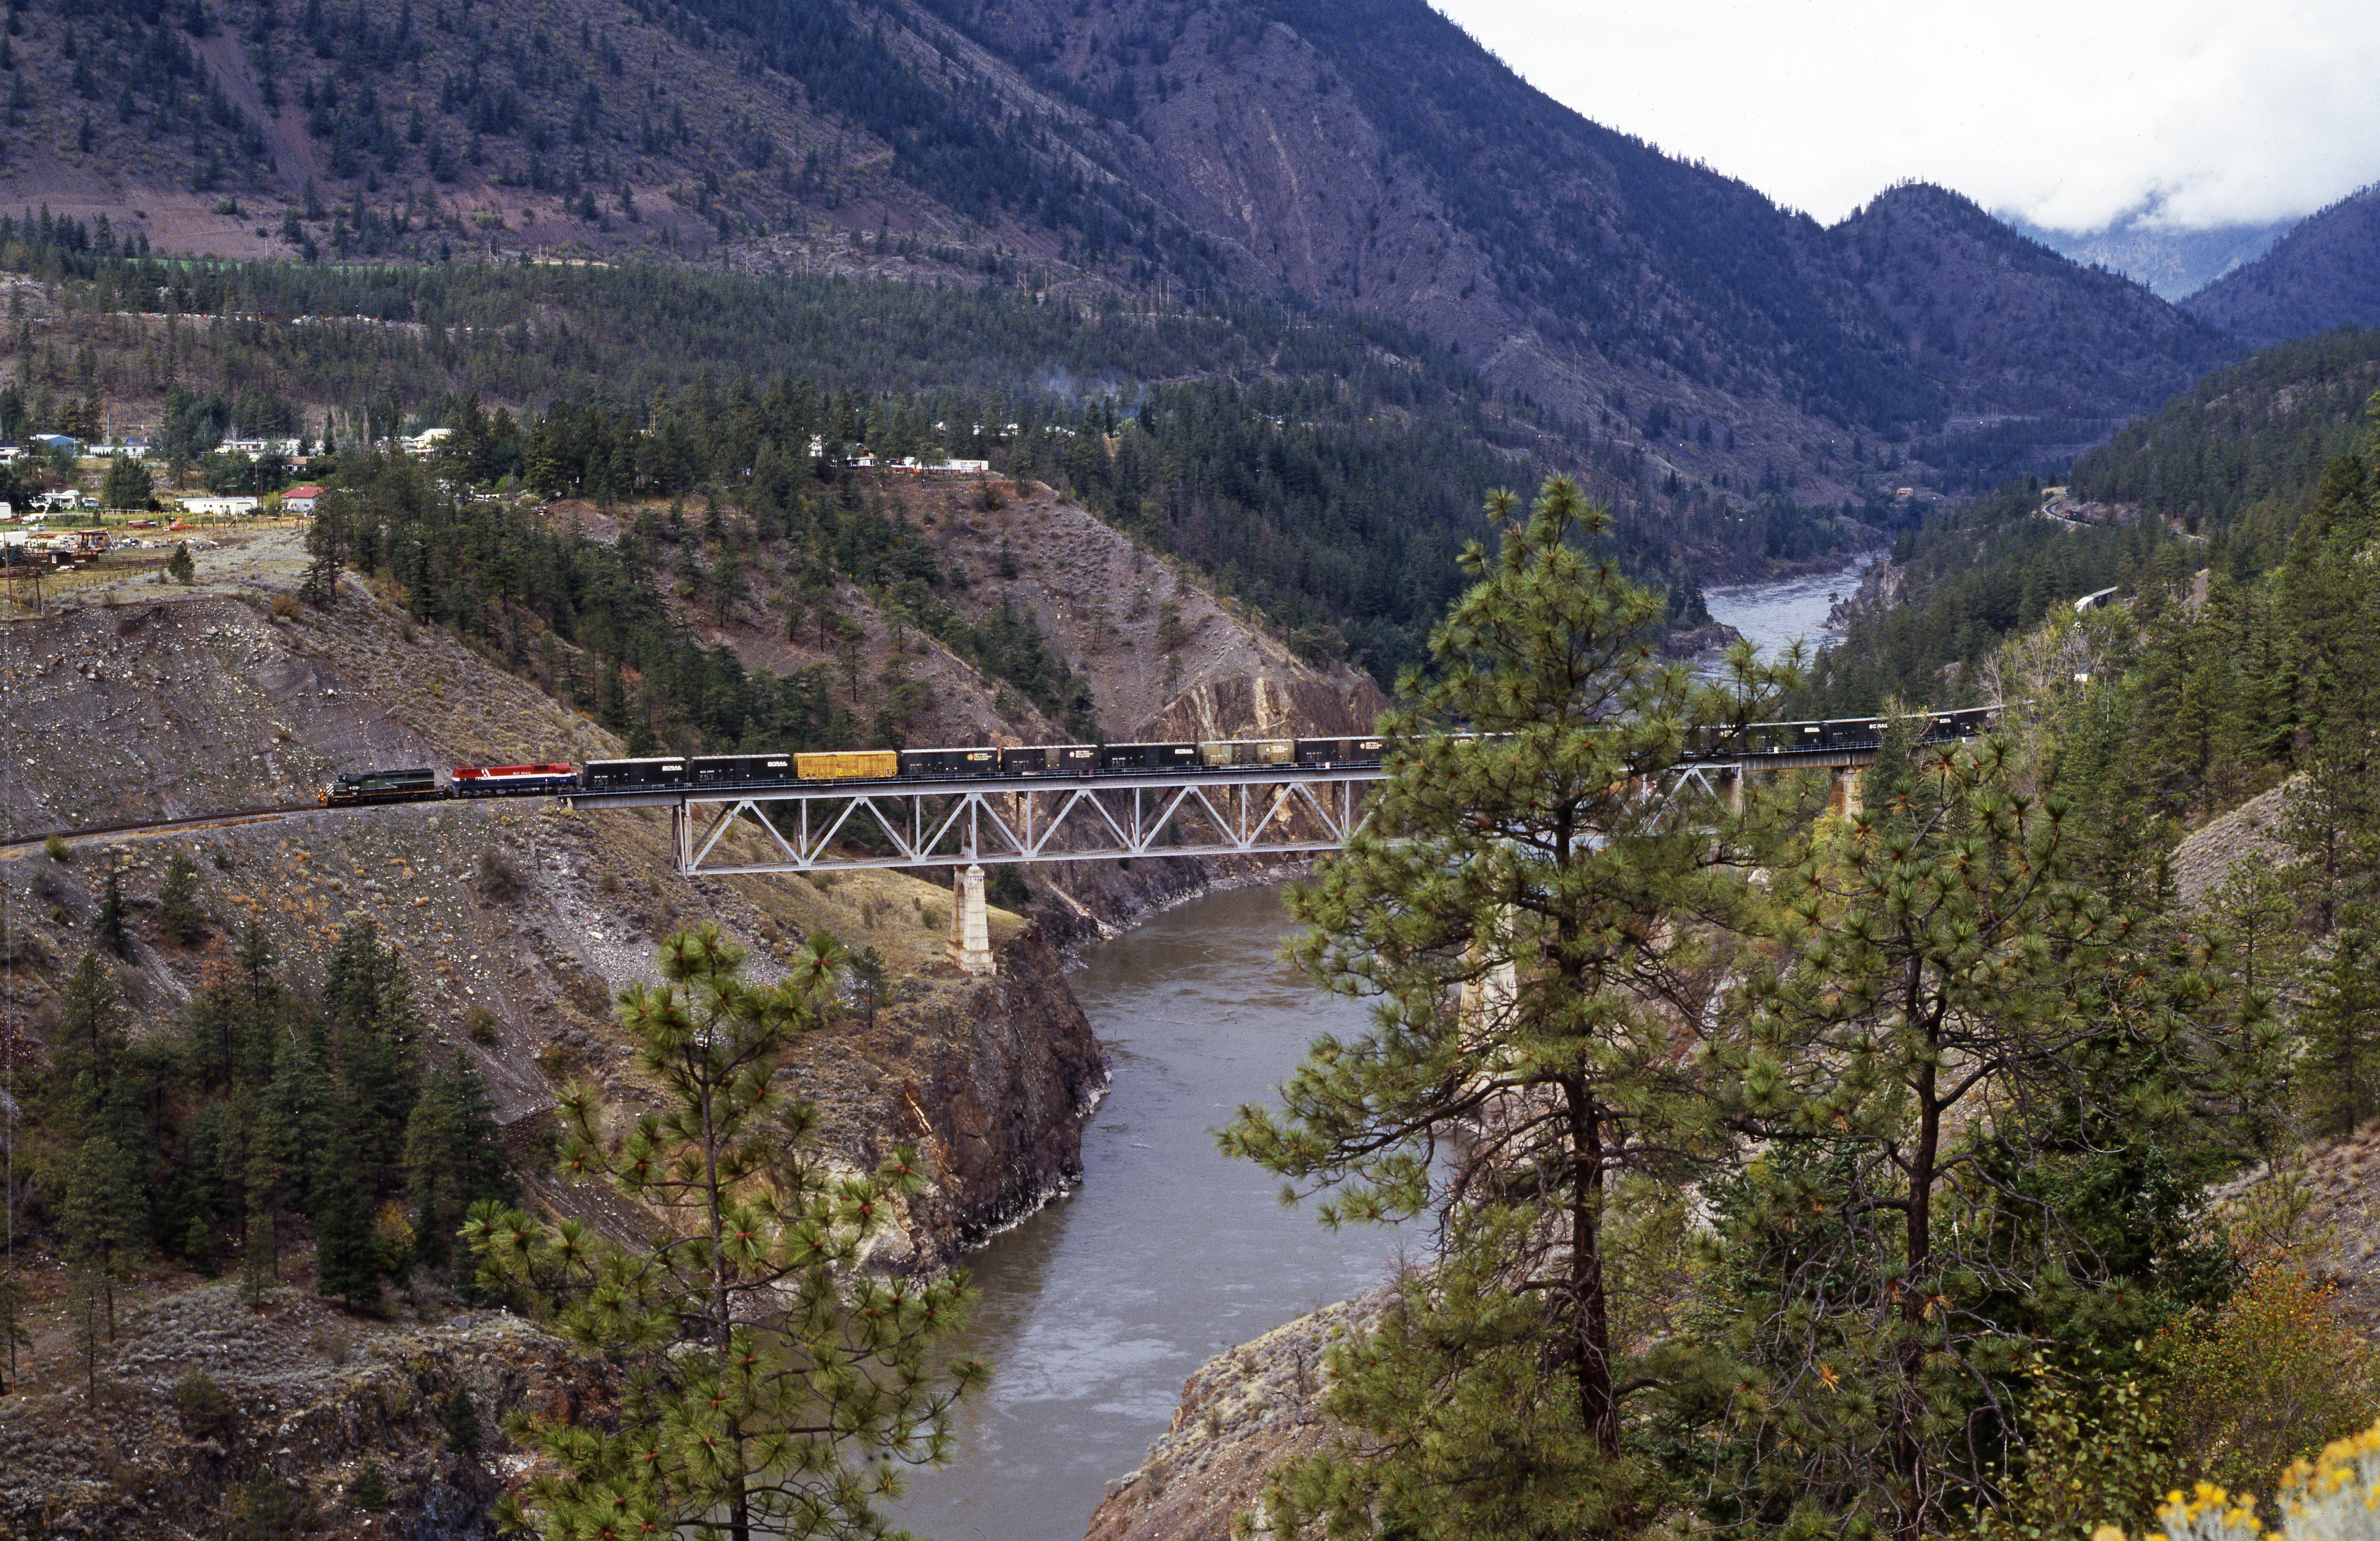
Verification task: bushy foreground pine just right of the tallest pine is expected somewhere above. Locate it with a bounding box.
[1714,739,2280,1541]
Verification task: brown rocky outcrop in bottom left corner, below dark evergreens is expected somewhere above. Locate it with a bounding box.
[0,1284,583,1541]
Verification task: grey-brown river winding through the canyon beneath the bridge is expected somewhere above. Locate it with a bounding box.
[895,558,1873,1541]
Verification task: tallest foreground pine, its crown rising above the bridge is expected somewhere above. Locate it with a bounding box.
[1221,479,1778,1539]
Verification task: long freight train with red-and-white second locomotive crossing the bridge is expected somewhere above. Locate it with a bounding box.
[321,707,1997,807]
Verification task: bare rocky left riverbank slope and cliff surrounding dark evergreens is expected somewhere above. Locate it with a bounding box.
[0,531,1107,1539]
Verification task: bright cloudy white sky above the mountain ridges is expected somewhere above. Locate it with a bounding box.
[1433,0,2380,231]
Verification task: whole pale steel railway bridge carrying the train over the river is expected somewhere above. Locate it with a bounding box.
[564,710,1987,876]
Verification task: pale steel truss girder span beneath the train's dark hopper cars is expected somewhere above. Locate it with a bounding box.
[619,767,1380,876]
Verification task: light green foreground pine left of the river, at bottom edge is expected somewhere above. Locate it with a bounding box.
[464,927,981,1541]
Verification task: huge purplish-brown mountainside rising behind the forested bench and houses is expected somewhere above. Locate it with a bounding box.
[0,0,2246,503]
